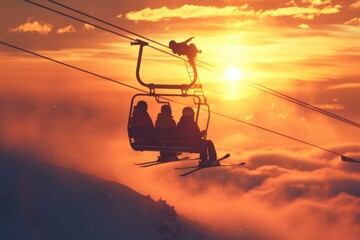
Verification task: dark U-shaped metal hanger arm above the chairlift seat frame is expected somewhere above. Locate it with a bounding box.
[131,39,198,93]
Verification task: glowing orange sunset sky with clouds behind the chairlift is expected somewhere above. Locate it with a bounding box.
[0,0,360,239]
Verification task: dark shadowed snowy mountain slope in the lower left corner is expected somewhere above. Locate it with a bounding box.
[0,153,212,240]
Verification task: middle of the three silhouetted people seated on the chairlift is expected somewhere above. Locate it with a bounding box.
[155,104,177,162]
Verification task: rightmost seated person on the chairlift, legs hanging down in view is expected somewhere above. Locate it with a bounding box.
[177,107,220,166]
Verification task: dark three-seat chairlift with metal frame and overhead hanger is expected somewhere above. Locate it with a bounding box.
[128,40,210,153]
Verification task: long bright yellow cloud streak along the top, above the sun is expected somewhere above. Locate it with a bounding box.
[126,4,253,22]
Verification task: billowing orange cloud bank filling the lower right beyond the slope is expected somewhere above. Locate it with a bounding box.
[162,144,360,240]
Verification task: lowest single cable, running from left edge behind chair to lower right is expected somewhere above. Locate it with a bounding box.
[0,41,359,162]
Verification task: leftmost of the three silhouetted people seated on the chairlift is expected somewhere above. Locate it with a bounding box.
[129,100,154,144]
